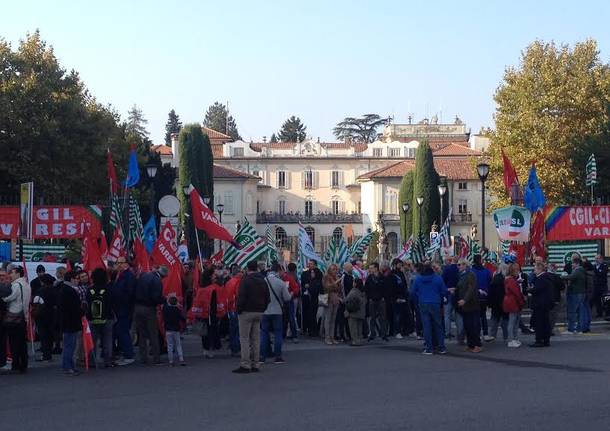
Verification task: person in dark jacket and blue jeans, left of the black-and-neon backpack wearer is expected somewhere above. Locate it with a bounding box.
[59,271,84,376]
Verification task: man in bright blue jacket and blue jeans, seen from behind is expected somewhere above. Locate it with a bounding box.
[412,262,448,355]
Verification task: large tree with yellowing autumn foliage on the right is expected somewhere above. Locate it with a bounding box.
[488,40,610,206]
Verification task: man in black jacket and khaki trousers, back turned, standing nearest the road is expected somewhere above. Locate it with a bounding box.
[233,260,270,374]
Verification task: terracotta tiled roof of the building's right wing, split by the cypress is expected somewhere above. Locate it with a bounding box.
[358,158,478,181]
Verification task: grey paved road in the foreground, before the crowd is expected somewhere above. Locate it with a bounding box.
[0,332,610,431]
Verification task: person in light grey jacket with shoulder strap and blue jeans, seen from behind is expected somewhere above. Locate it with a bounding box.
[260,262,292,364]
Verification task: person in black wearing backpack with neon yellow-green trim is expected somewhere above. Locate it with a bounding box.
[87,268,115,368]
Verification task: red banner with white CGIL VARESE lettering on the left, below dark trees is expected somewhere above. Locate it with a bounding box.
[0,205,102,239]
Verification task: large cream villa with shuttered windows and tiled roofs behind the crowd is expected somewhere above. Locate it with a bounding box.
[155,117,495,260]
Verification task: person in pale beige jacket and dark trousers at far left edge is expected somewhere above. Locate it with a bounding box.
[2,266,32,374]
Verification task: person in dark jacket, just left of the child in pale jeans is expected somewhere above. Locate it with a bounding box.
[134,266,169,365]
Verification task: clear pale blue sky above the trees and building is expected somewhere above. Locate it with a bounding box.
[0,0,610,143]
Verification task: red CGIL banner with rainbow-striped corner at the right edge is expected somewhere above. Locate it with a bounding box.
[544,205,610,241]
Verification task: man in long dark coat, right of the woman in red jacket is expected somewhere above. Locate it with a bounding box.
[529,262,553,347]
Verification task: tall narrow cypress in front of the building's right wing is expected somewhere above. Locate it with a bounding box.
[411,140,440,235]
